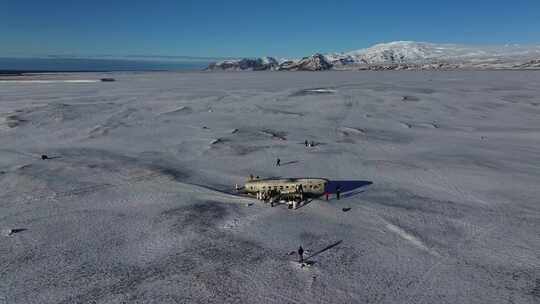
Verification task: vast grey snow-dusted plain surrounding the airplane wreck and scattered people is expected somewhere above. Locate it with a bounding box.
[0,71,540,304]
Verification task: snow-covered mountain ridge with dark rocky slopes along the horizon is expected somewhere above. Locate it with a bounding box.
[207,41,540,71]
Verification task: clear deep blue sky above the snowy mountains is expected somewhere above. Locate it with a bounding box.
[0,0,540,57]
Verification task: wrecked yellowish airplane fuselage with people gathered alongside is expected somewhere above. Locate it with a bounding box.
[244,178,328,209]
